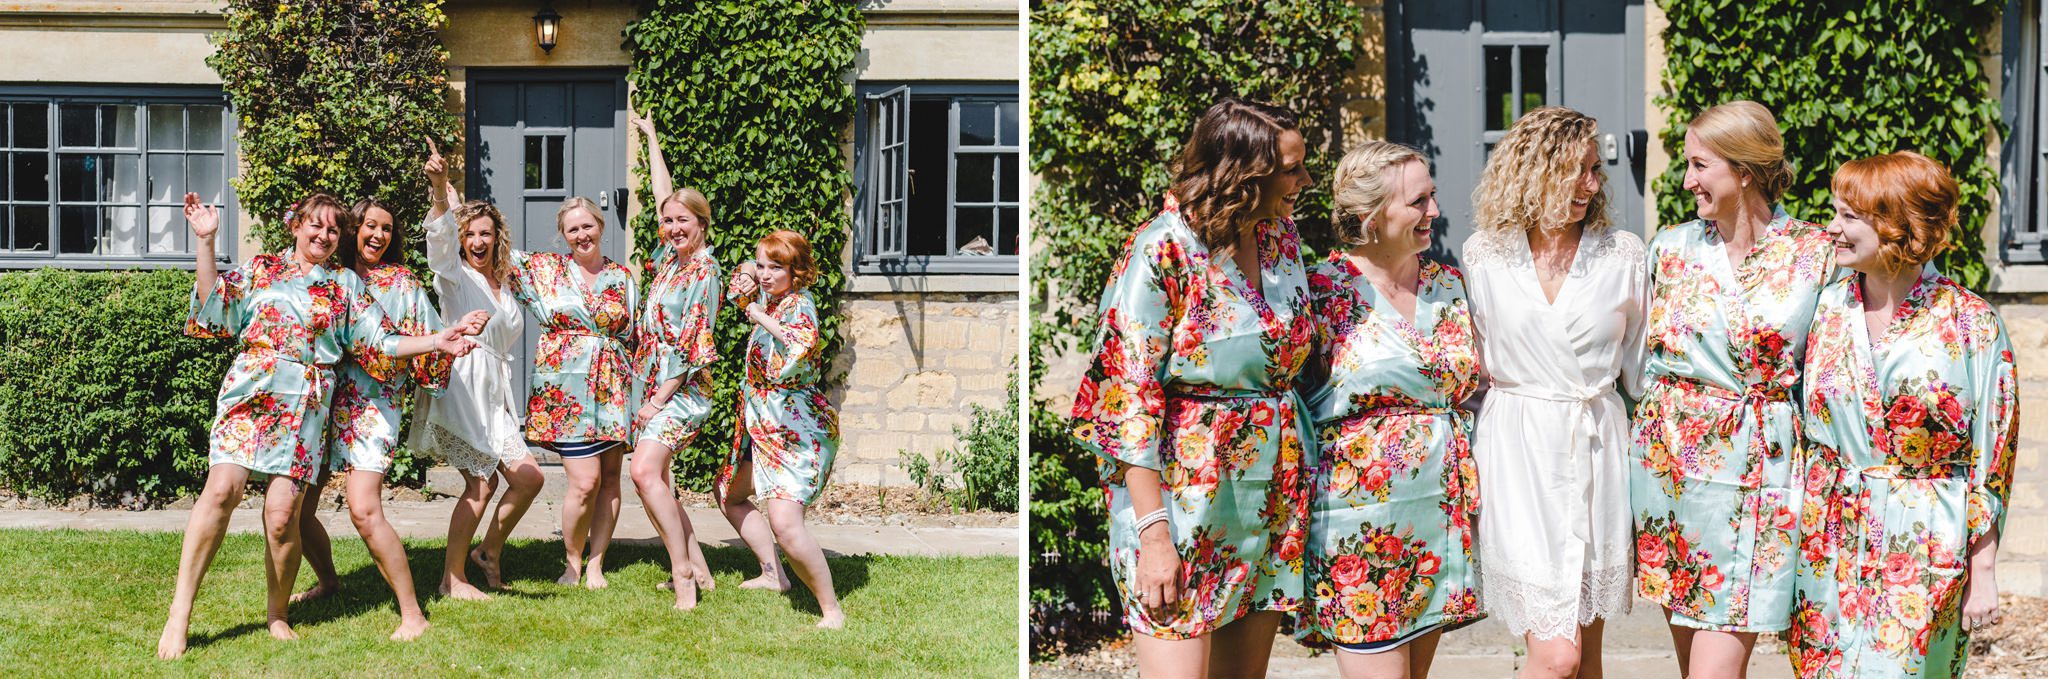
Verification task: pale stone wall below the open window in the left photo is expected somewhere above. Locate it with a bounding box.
[831,292,1018,485]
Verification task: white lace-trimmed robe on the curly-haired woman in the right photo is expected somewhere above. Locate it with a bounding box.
[1462,229,1649,638]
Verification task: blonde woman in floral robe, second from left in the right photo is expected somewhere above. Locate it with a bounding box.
[1303,141,1481,677]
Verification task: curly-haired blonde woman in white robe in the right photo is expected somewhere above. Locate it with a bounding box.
[1464,106,1649,677]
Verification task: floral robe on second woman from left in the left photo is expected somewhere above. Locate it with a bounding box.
[328,264,455,472]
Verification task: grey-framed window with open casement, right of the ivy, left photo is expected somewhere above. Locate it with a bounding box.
[858,86,1022,274]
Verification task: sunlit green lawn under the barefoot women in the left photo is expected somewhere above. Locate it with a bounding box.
[0,530,1018,677]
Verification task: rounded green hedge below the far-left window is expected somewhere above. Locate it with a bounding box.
[0,268,233,503]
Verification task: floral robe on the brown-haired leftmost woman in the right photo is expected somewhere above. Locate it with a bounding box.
[1073,196,1315,638]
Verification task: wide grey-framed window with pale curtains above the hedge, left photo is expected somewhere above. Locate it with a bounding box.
[0,92,229,262]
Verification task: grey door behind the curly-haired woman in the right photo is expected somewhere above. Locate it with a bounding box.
[1386,0,1649,262]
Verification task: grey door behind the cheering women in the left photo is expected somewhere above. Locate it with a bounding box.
[467,70,631,405]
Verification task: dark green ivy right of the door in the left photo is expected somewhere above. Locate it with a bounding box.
[625,0,864,491]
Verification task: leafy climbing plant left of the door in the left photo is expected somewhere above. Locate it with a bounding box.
[207,0,461,259]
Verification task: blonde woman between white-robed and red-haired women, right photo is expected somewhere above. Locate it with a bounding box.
[1628,102,1835,677]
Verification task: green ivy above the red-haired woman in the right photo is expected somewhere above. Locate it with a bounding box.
[1651,0,2005,288]
